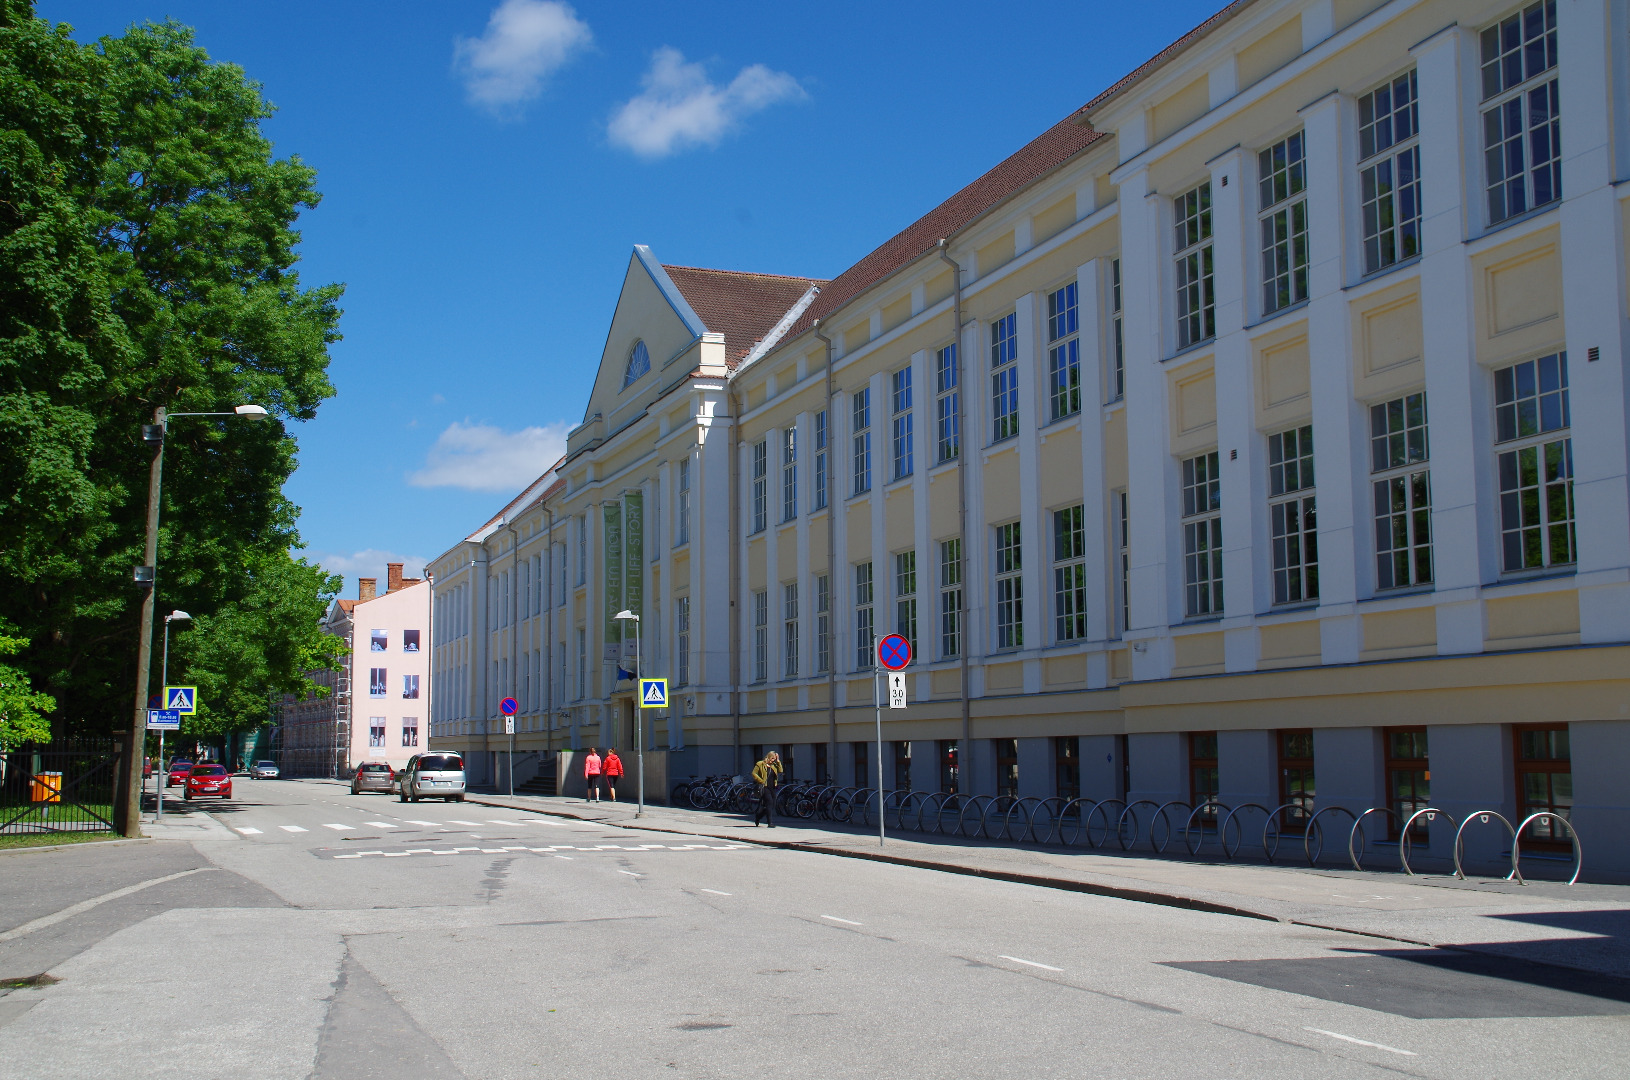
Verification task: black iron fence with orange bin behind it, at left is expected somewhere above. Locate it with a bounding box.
[0,740,119,834]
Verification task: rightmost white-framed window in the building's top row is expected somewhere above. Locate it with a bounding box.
[1478,0,1562,225]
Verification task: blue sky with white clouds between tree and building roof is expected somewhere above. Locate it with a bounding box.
[37,0,1221,595]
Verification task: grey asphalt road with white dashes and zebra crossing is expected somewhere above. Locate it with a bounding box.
[0,779,1630,1080]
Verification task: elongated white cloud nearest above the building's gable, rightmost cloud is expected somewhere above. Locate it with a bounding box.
[608,46,807,158]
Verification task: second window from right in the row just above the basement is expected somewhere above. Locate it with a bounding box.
[1369,391,1431,588]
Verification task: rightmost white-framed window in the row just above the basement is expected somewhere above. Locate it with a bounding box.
[1495,352,1578,573]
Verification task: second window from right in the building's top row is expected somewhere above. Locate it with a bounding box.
[1358,72,1421,274]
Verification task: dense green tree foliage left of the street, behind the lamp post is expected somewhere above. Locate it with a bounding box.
[0,0,342,730]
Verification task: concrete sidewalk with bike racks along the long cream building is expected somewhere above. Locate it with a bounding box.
[468,793,1630,977]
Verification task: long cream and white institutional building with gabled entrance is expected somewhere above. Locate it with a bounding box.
[429,0,1630,868]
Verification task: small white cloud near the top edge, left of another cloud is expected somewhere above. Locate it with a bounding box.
[453,0,593,109]
